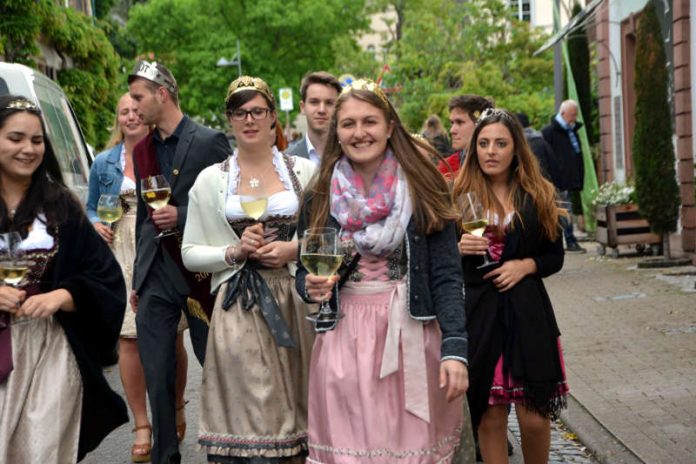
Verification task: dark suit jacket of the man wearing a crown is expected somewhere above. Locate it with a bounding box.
[133,118,232,292]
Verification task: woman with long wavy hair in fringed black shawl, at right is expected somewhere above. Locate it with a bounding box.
[453,109,568,464]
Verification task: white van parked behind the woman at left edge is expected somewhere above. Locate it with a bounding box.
[0,62,92,204]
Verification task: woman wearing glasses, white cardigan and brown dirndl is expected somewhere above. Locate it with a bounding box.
[182,76,314,463]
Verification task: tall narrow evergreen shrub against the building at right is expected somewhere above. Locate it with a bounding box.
[633,2,679,243]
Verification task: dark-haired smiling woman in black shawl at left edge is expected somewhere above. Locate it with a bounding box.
[0,96,128,464]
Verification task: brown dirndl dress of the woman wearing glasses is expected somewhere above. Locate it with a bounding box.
[198,215,314,463]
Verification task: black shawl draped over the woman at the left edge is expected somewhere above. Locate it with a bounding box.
[51,198,128,460]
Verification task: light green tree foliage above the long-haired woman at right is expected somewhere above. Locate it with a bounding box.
[386,0,554,132]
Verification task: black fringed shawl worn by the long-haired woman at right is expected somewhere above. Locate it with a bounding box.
[462,194,564,430]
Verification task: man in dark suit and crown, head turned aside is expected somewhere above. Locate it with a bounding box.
[128,61,230,464]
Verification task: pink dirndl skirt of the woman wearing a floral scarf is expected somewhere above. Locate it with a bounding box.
[308,282,463,464]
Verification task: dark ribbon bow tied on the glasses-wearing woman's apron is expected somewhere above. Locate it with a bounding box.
[222,265,297,348]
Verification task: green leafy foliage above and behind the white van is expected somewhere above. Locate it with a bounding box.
[0,0,120,147]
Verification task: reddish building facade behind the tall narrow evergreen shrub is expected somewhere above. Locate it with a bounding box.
[595,0,696,253]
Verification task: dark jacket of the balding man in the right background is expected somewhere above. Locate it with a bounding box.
[541,116,585,192]
